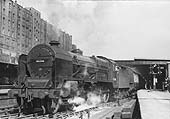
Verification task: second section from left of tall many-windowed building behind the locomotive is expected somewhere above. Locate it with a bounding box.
[17,5,33,54]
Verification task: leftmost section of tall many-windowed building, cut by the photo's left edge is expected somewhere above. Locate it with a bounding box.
[0,0,17,51]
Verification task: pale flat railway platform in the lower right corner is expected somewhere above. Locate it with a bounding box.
[137,90,170,119]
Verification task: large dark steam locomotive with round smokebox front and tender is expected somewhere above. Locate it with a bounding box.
[8,41,139,113]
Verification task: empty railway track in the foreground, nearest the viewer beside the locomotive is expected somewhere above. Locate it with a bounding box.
[0,97,135,119]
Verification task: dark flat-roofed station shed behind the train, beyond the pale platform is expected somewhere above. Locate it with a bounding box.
[115,59,170,90]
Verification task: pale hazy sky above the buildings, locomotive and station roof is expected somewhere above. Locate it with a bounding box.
[17,0,170,59]
